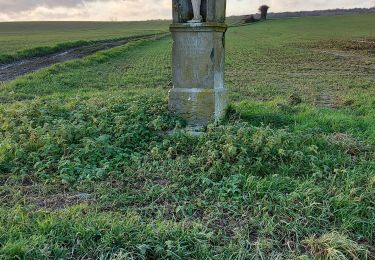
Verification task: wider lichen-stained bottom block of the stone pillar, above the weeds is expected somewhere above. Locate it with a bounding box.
[169,88,227,126]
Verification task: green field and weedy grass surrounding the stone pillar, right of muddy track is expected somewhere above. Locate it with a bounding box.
[0,15,375,259]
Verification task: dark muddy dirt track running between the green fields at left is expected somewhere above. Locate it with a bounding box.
[0,34,166,83]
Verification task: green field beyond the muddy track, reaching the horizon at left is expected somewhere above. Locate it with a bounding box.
[0,21,170,64]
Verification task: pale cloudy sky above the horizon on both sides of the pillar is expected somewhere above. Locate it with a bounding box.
[0,0,375,21]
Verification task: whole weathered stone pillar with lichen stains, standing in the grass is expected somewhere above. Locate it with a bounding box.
[169,0,227,127]
